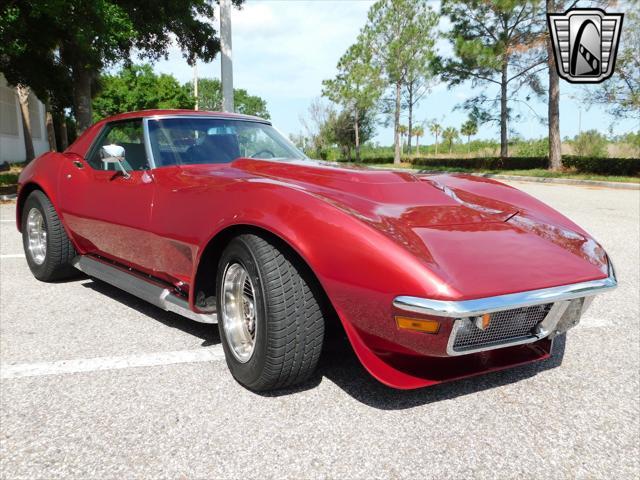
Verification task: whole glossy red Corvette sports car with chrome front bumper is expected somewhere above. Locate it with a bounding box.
[17,111,616,390]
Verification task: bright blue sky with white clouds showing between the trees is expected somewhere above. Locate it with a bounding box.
[154,0,640,145]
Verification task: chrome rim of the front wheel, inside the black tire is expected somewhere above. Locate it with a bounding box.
[221,263,258,363]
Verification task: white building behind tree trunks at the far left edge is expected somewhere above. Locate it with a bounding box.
[0,73,49,164]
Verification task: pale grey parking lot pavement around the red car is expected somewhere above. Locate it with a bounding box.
[0,182,640,479]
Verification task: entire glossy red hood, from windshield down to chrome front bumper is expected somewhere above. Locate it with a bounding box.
[233,159,608,298]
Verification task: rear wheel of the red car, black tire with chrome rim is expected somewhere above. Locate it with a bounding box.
[22,190,77,282]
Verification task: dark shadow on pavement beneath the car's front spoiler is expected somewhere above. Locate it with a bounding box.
[318,335,566,410]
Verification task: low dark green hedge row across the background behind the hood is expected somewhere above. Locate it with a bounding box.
[338,155,640,176]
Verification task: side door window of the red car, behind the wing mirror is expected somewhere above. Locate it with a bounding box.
[87,119,149,170]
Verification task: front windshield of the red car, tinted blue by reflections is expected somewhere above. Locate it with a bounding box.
[149,117,306,167]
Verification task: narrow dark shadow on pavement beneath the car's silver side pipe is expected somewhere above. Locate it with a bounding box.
[81,277,220,347]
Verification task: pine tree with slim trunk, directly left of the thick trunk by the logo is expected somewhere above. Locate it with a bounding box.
[436,0,545,157]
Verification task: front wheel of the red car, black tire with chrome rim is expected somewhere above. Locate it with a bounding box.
[216,234,324,391]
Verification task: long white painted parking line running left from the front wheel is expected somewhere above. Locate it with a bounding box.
[0,345,224,380]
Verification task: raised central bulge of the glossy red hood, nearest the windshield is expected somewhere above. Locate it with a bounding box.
[234,159,518,227]
